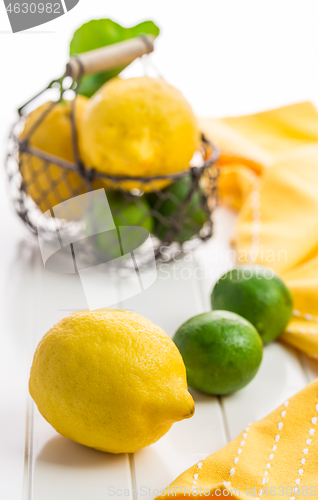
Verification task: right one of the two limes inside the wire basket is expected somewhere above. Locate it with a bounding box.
[148,175,209,243]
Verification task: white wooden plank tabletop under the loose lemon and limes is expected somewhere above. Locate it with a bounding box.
[0,197,318,500]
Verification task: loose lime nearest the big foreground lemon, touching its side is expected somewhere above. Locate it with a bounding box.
[173,311,263,395]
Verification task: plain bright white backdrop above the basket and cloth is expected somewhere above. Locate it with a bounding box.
[0,0,318,229]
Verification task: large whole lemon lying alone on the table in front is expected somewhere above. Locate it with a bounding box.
[29,309,194,453]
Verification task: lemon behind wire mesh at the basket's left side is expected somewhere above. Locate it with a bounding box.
[20,96,88,212]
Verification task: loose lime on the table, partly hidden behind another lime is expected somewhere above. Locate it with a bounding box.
[211,266,293,343]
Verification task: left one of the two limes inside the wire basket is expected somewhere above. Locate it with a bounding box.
[86,191,154,259]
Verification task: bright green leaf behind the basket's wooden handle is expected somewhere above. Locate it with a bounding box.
[70,19,160,97]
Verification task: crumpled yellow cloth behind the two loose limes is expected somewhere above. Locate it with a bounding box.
[200,102,318,357]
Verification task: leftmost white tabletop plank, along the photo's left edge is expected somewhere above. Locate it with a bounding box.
[0,237,34,500]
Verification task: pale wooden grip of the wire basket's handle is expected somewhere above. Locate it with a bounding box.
[66,35,154,79]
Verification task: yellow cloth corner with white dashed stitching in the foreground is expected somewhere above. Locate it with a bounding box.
[157,380,318,500]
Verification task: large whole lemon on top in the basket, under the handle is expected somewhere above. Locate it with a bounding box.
[80,77,199,191]
